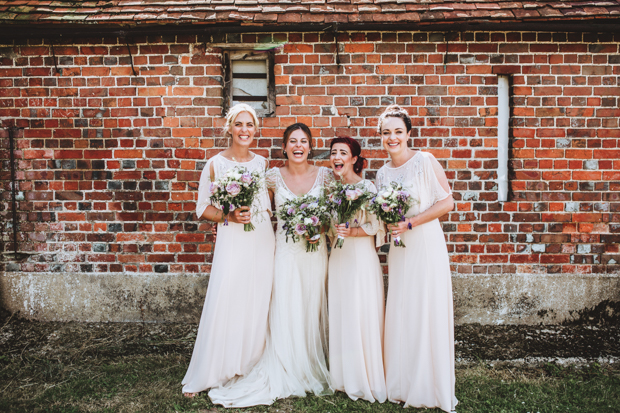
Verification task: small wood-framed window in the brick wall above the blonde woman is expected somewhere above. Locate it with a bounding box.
[223,50,276,117]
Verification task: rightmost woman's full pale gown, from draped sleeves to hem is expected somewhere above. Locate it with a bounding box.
[377,152,457,412]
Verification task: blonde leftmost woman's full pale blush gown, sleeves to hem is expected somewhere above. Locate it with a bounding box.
[182,154,275,393]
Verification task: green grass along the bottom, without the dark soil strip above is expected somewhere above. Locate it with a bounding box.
[0,352,620,413]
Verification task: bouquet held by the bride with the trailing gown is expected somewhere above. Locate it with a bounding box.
[277,195,331,252]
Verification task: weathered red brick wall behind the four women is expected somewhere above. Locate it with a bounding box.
[0,32,620,286]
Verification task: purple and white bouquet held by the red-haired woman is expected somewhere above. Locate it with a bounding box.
[327,181,375,248]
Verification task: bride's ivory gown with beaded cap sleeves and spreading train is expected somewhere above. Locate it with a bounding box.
[209,167,333,407]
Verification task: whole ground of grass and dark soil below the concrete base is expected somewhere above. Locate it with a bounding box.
[0,318,620,413]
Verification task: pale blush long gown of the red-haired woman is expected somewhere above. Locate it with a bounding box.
[328,180,386,403]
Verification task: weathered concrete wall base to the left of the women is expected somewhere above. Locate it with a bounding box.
[0,272,209,323]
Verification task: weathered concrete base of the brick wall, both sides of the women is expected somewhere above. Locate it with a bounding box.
[0,272,620,325]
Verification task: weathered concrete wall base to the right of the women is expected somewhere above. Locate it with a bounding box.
[452,274,620,325]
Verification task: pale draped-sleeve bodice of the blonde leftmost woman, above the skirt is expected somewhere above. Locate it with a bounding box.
[196,154,271,220]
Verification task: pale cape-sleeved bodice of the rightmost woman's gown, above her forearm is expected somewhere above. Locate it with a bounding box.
[377,151,452,217]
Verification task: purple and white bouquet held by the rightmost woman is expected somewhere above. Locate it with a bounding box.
[368,182,413,247]
